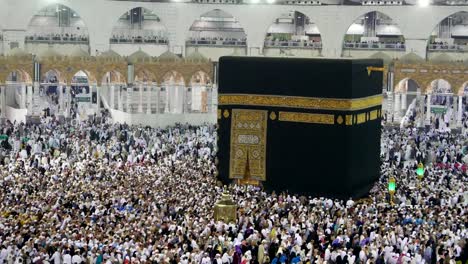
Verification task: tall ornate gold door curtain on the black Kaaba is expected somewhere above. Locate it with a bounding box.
[229,109,268,181]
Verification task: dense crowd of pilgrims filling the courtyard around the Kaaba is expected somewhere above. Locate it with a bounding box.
[0,114,468,264]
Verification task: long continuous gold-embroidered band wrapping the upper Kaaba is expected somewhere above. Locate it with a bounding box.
[218,94,383,111]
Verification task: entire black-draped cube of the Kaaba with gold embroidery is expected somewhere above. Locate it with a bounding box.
[218,57,383,199]
